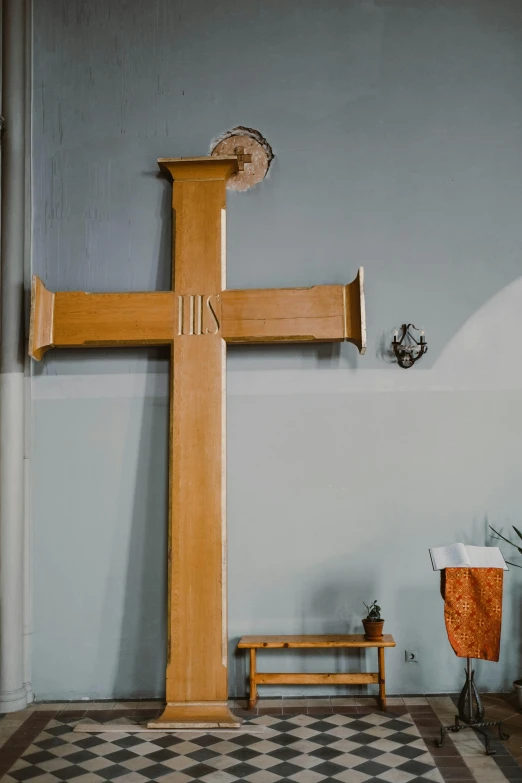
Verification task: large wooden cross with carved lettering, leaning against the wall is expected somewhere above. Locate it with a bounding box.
[29,155,365,728]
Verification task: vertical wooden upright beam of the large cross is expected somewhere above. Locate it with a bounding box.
[156,158,238,726]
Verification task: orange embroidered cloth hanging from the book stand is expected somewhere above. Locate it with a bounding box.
[441,568,504,661]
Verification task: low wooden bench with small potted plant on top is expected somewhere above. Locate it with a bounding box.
[237,634,395,710]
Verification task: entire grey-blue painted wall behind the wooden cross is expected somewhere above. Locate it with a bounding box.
[32,0,522,698]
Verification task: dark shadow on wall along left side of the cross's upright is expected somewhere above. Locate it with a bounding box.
[114,180,172,698]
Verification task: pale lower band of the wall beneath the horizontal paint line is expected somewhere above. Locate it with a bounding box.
[33,370,522,698]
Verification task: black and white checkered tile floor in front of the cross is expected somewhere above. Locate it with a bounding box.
[3,712,442,783]
